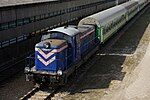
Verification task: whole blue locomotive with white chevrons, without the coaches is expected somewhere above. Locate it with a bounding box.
[25,25,99,84]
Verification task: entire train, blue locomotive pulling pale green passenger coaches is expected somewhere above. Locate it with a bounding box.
[25,0,149,85]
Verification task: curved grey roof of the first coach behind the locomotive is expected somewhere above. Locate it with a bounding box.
[78,5,126,26]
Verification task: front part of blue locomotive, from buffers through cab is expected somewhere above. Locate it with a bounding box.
[25,27,80,84]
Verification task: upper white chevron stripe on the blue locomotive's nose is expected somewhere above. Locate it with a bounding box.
[35,45,68,59]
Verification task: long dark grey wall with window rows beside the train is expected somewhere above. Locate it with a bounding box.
[0,0,126,42]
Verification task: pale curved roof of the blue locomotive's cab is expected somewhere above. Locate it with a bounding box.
[48,25,79,37]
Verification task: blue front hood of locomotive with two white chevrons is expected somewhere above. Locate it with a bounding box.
[35,39,68,72]
